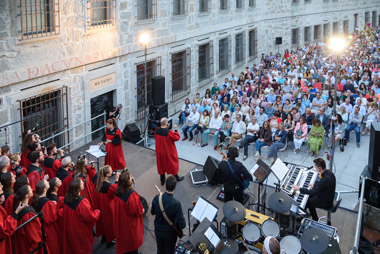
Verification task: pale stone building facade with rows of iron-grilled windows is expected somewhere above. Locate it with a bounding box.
[0,0,380,150]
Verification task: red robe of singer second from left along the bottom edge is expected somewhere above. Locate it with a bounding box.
[12,206,43,254]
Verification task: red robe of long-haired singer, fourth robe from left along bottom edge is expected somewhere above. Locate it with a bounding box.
[60,197,100,254]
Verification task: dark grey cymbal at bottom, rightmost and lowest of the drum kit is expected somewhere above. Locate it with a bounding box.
[300,228,329,254]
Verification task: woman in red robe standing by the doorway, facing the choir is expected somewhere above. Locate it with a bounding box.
[98,118,125,171]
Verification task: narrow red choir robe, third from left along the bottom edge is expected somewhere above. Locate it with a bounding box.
[37,197,61,254]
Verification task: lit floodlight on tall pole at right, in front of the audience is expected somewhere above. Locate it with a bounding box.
[328,37,347,171]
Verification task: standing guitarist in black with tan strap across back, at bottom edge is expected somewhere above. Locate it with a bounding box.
[151,175,186,254]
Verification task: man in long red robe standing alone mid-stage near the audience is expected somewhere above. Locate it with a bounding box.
[154,117,183,185]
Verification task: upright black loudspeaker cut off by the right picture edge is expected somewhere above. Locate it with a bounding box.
[368,122,380,180]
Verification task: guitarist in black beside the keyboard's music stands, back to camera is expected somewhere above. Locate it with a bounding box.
[218,146,253,205]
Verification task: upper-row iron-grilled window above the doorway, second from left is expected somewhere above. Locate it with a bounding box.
[87,0,115,27]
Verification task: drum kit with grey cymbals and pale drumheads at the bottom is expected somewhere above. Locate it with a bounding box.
[220,192,340,254]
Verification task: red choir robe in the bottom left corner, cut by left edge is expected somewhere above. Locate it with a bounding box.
[0,206,17,254]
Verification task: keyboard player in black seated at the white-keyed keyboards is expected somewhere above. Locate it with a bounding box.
[291,158,336,221]
